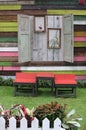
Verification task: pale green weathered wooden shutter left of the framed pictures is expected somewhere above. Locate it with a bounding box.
[18,15,31,62]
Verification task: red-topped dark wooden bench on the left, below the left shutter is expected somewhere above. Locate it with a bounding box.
[13,72,36,96]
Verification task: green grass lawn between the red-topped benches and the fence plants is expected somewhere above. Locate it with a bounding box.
[0,86,86,130]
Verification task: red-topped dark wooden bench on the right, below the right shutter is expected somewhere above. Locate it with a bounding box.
[54,74,77,97]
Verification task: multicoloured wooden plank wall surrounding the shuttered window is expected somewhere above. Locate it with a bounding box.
[0,5,86,80]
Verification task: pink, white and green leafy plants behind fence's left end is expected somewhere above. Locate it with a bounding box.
[0,104,33,128]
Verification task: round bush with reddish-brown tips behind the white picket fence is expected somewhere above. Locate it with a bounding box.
[34,102,66,127]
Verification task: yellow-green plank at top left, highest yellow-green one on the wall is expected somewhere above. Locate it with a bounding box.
[0,4,21,10]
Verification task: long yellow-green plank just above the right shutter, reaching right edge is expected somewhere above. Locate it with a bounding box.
[47,9,86,15]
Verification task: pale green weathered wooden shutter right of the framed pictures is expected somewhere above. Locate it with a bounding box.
[63,15,74,62]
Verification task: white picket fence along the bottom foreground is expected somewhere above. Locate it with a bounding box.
[0,117,65,130]
